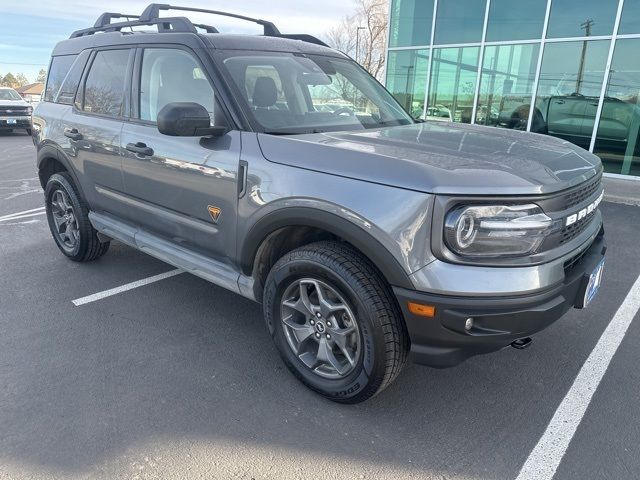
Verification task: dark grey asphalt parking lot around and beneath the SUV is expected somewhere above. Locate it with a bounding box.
[0,129,640,480]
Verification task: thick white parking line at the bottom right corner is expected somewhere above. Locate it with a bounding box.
[516,277,640,480]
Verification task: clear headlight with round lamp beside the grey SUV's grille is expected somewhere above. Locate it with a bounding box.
[444,204,553,257]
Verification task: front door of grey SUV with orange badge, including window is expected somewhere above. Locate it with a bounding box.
[121,48,240,259]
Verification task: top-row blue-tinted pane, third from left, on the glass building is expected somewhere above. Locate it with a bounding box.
[487,0,547,42]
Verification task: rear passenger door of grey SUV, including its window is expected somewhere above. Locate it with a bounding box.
[63,47,134,215]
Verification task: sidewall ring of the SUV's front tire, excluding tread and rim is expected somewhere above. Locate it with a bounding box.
[264,255,384,401]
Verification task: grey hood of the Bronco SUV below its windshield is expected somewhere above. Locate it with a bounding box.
[258,122,602,195]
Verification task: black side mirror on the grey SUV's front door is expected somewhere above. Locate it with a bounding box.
[158,102,228,137]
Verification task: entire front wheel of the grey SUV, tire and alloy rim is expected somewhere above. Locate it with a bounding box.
[263,242,409,403]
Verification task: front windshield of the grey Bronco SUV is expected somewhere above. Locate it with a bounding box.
[223,52,414,135]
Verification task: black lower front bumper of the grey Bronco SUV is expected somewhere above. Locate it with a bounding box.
[394,229,606,368]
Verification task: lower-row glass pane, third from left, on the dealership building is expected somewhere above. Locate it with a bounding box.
[476,44,540,130]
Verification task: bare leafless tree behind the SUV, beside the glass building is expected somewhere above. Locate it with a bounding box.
[326,0,389,80]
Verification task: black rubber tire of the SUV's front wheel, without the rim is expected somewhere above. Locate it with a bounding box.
[263,242,409,404]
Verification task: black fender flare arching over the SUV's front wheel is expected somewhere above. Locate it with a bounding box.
[240,207,415,290]
